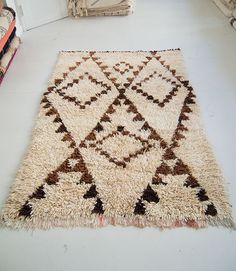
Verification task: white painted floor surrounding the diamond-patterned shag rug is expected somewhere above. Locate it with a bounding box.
[0,0,236,271]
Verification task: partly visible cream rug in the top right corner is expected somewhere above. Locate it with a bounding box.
[213,0,236,29]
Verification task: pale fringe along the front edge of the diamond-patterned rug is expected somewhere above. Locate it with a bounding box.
[0,215,236,230]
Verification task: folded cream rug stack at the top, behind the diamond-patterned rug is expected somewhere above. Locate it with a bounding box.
[68,0,134,17]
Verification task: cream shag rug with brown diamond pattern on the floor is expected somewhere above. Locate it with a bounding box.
[1,49,234,228]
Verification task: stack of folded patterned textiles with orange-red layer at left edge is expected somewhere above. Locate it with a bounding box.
[0,7,20,84]
